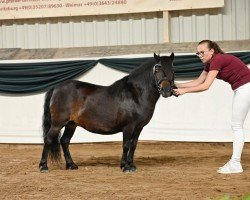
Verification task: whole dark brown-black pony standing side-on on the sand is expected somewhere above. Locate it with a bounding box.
[39,53,174,172]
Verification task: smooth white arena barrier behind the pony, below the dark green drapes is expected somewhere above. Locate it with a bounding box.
[0,55,250,143]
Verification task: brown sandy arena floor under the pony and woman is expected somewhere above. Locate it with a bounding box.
[0,141,250,200]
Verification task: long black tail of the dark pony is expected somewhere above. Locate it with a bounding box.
[43,89,61,162]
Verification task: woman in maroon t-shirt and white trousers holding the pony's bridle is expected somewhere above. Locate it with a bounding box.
[174,40,250,174]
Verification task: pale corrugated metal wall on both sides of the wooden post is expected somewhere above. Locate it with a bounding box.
[0,0,250,49]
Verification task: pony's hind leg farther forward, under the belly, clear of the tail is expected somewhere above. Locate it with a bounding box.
[60,122,78,169]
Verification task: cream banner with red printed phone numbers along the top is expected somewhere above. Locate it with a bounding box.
[0,0,224,20]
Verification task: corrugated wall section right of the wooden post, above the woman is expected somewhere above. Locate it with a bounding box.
[171,0,250,43]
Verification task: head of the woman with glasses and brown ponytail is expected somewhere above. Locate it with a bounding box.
[196,40,224,63]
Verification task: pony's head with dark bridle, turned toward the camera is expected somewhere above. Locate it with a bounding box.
[153,53,176,97]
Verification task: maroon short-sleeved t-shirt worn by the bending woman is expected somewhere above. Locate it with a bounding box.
[204,53,250,90]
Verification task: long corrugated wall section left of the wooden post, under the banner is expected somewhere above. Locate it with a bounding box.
[0,12,163,49]
